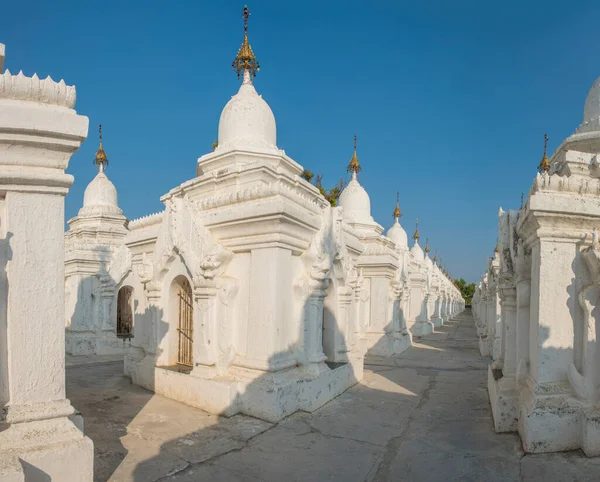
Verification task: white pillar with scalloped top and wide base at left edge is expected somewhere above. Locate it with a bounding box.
[0,46,93,481]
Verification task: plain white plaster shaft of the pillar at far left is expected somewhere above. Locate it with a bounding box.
[6,191,65,404]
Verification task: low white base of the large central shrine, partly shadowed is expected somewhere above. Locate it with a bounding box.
[125,355,363,422]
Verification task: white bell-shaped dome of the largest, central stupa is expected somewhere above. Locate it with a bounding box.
[217,70,277,149]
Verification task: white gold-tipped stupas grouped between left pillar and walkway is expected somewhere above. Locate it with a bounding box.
[65,9,464,421]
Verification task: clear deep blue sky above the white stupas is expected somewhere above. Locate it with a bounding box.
[0,0,600,281]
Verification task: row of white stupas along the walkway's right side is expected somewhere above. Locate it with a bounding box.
[473,75,600,456]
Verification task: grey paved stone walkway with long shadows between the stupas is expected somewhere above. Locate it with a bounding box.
[67,312,600,482]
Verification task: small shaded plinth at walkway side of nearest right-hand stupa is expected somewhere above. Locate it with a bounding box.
[488,366,519,433]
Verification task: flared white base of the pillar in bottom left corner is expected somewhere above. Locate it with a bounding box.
[0,417,94,482]
